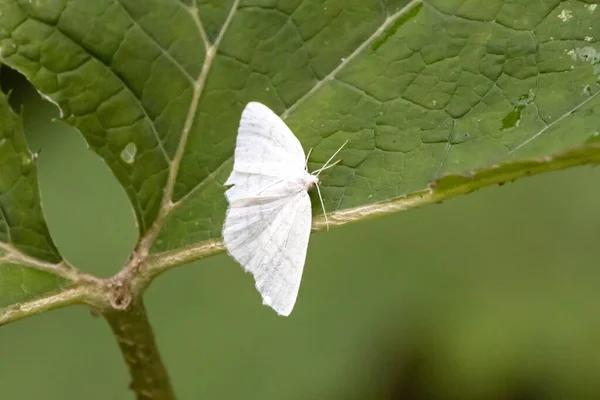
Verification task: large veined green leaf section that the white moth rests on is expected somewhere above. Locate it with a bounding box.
[0,0,600,262]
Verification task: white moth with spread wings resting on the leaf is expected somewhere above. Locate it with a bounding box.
[223,102,346,316]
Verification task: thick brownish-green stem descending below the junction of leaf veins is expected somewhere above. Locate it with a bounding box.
[104,298,175,400]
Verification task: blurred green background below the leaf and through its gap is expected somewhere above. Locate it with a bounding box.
[0,69,600,400]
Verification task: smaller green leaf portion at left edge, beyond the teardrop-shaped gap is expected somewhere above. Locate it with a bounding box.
[0,85,66,310]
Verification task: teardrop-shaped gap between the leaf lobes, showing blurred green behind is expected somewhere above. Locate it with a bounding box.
[0,66,137,276]
